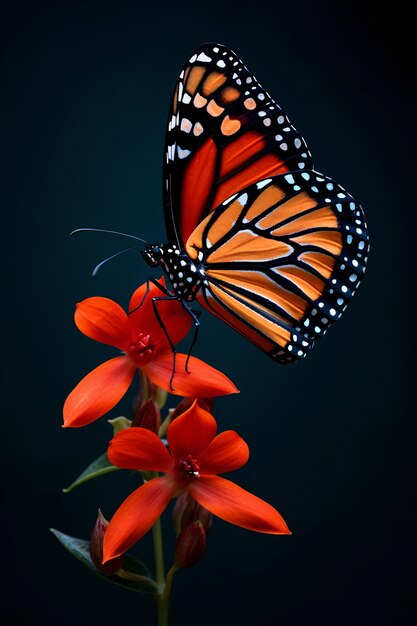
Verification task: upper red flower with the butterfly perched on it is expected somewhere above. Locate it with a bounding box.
[64,284,238,426]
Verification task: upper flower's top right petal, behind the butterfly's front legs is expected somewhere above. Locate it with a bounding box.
[129,279,192,350]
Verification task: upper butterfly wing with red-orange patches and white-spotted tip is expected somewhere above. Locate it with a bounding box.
[163,44,312,249]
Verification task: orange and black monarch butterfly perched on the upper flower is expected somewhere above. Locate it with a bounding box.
[142,44,369,364]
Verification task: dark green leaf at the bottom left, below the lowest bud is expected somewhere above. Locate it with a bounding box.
[50,528,158,594]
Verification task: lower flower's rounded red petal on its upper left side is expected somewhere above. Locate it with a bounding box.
[107,427,172,472]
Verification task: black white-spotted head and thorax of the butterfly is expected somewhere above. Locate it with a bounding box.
[142,244,204,302]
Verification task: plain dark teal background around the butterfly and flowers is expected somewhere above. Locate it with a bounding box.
[0,0,416,626]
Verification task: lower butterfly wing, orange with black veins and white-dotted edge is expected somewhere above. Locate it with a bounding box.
[186,170,368,363]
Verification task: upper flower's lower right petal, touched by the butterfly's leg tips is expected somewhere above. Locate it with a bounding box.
[143,351,239,398]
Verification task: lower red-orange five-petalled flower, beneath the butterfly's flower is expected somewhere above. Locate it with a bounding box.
[103,402,290,562]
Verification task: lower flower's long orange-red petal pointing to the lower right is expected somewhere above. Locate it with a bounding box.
[188,476,291,535]
